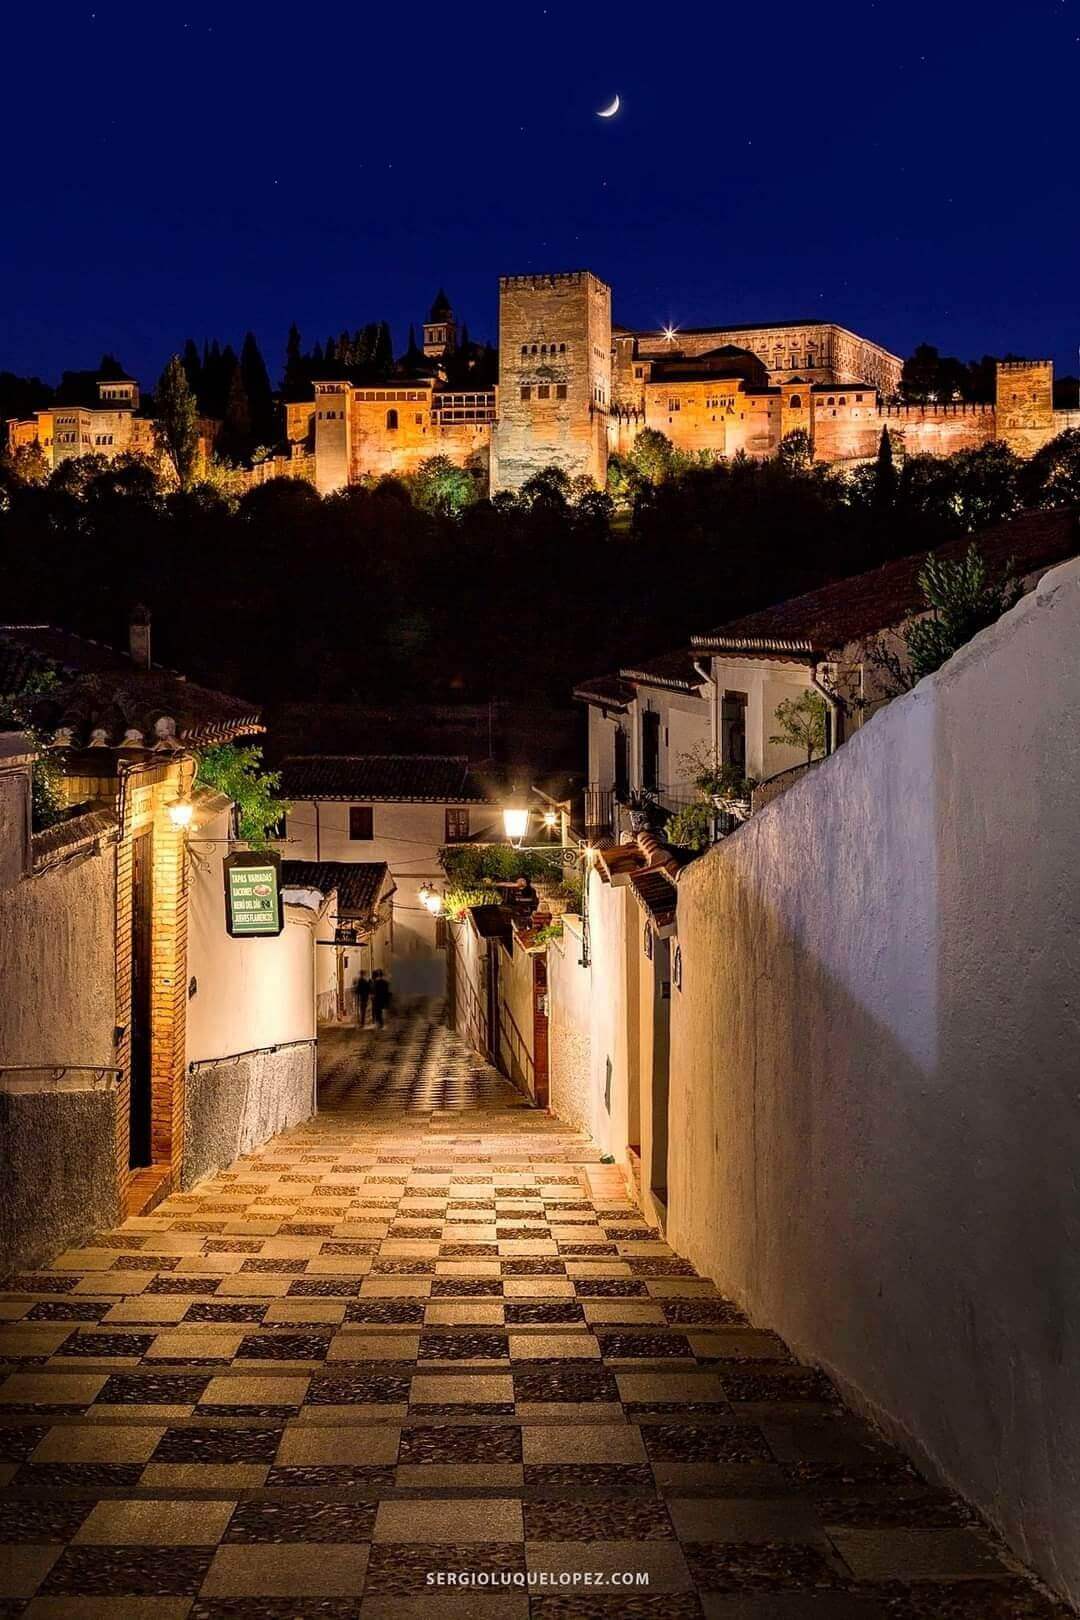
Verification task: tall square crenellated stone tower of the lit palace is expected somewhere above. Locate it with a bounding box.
[491,271,612,492]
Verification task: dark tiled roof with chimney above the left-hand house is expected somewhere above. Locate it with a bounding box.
[0,624,264,750]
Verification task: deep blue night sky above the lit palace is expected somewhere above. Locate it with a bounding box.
[0,0,1080,384]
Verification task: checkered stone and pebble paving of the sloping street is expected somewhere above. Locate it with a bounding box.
[0,1004,1064,1620]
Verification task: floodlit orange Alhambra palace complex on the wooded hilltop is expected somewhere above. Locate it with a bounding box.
[8,271,1080,494]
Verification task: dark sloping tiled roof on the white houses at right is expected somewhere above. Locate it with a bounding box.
[691,507,1080,661]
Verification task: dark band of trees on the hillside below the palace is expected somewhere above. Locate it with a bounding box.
[0,433,1080,716]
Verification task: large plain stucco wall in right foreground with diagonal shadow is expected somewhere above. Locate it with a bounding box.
[669,564,1080,1601]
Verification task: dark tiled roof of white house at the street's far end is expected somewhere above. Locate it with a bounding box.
[282,753,487,804]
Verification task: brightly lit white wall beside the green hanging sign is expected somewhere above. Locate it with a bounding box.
[186,812,318,1063]
